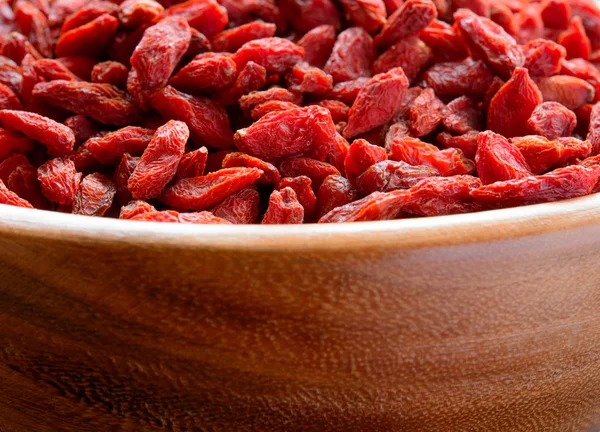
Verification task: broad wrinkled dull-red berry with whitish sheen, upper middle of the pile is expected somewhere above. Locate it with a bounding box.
[325,27,375,84]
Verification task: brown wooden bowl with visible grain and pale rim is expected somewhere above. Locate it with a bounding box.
[0,200,600,432]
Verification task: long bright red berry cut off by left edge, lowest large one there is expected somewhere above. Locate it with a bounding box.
[0,110,75,156]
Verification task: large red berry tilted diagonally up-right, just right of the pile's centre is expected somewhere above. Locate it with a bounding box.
[344,68,408,138]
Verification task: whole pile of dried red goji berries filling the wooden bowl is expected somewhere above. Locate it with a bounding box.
[0,0,600,224]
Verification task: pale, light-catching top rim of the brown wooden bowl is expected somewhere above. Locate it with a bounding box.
[0,193,600,251]
